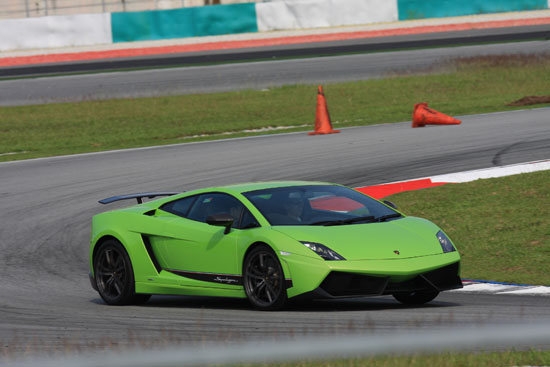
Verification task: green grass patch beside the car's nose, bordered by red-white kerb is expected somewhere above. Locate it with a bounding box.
[388,171,550,286]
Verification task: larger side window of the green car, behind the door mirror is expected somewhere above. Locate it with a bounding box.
[186,193,258,228]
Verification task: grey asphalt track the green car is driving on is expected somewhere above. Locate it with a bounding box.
[0,109,550,355]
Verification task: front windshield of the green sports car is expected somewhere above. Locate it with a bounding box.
[244,185,401,226]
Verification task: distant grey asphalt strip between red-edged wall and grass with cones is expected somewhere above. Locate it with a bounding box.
[0,41,550,106]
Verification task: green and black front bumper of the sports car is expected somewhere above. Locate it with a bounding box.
[283,251,462,298]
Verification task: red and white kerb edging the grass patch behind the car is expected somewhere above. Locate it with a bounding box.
[356,160,550,296]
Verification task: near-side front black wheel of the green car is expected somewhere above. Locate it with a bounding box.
[243,246,287,311]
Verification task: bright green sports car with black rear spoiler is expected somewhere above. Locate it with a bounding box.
[90,182,462,310]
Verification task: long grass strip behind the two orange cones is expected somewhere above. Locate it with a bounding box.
[0,55,550,161]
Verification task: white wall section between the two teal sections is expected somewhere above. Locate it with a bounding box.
[256,0,397,32]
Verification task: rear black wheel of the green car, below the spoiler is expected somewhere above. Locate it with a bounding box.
[94,239,151,306]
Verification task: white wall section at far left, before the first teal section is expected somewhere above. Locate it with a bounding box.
[0,13,112,51]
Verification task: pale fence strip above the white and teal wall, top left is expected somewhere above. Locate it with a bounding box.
[0,0,262,19]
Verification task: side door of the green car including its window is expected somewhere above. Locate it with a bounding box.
[152,192,260,284]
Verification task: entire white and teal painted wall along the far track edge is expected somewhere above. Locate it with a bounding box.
[0,0,550,51]
